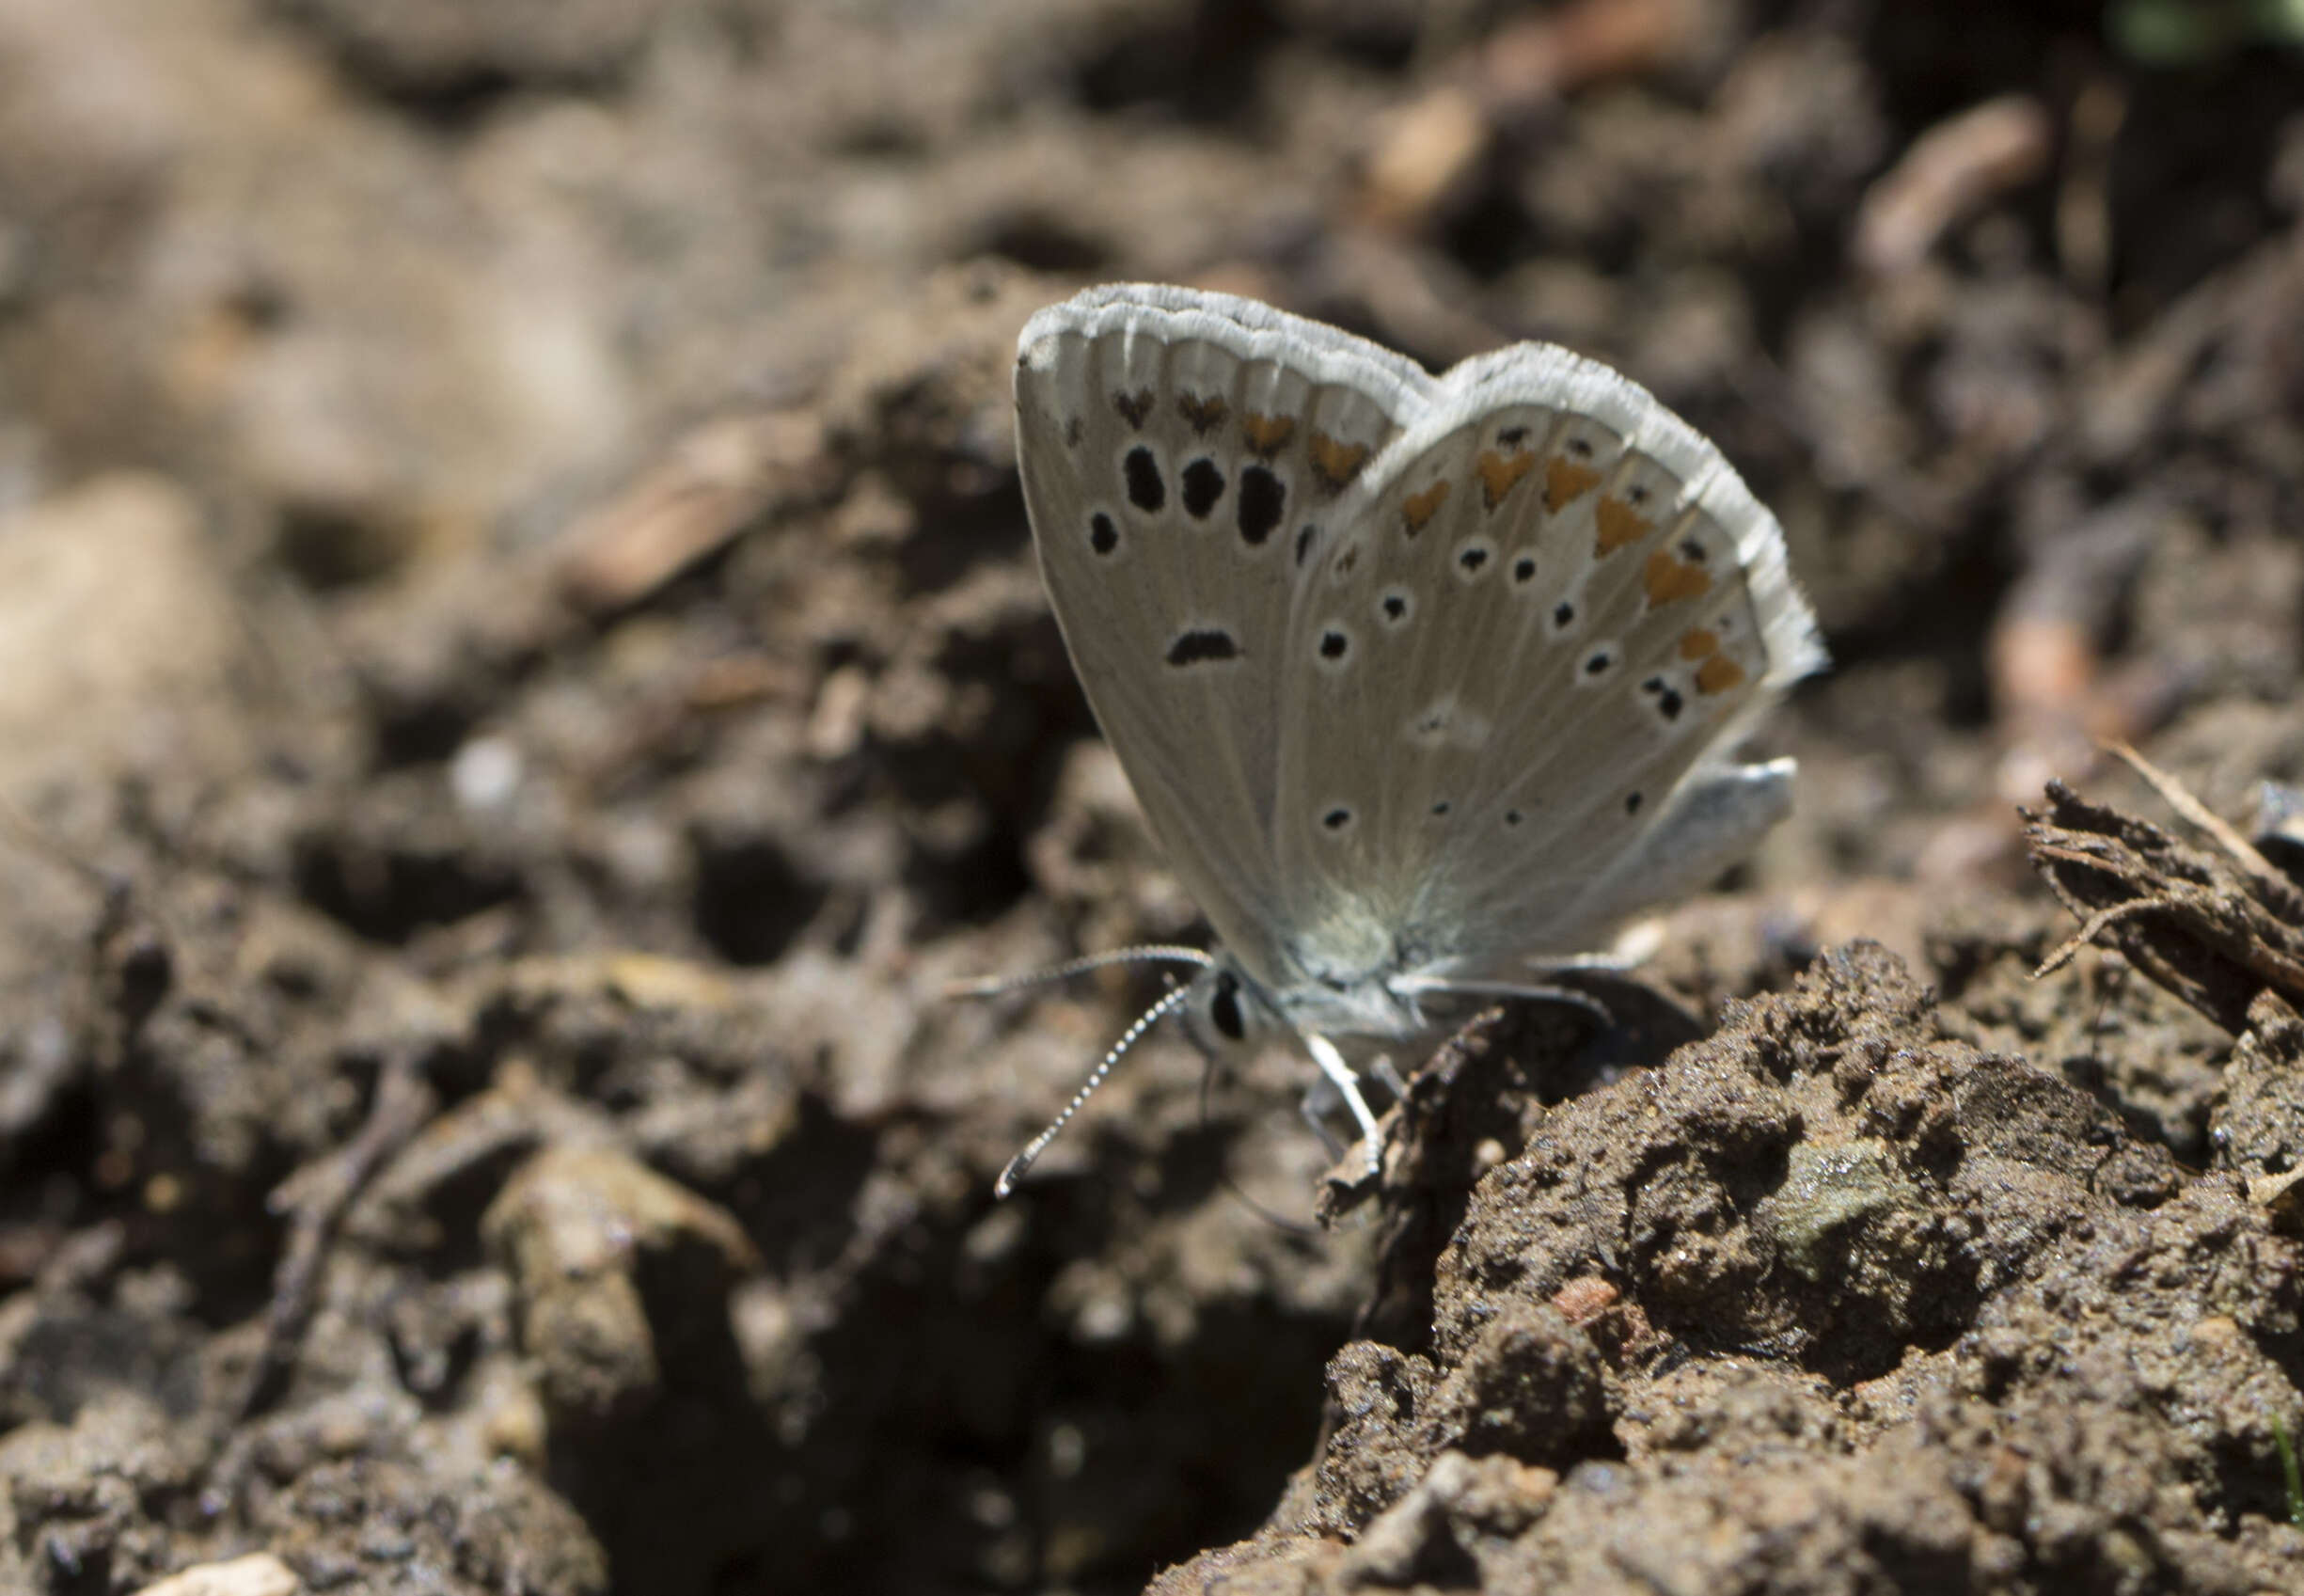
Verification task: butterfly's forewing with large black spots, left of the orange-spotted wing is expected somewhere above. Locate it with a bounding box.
[1016,288,1430,984]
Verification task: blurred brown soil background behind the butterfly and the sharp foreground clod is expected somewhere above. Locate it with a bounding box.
[0,0,2304,1596]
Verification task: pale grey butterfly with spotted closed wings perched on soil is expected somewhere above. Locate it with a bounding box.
[968,283,1824,1195]
